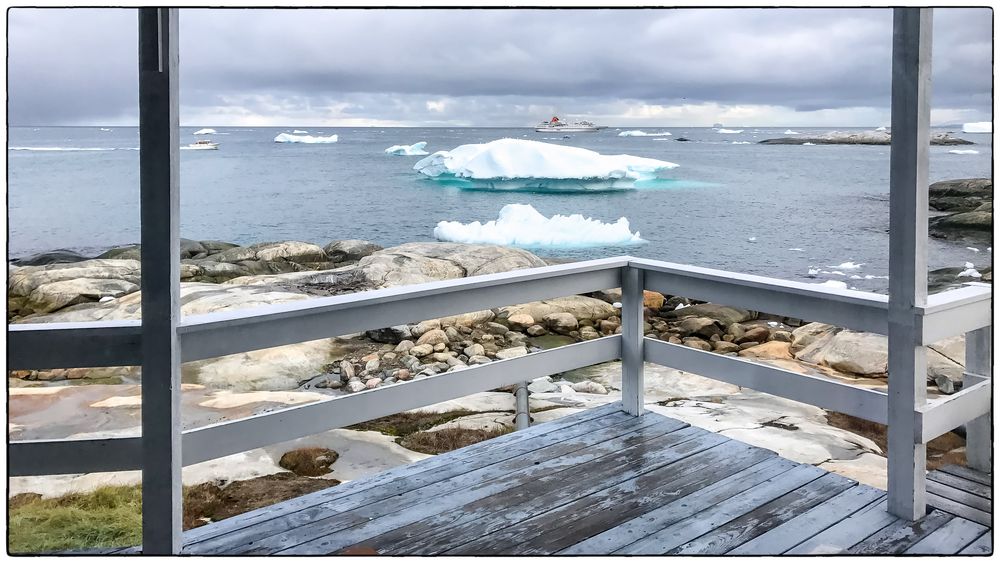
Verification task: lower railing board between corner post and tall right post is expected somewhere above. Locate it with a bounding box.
[645,338,887,424]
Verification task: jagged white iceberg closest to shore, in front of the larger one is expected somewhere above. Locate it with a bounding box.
[434,203,646,248]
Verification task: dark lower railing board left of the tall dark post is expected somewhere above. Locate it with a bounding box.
[7,437,142,477]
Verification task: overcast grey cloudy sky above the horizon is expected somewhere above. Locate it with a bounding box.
[7,8,993,126]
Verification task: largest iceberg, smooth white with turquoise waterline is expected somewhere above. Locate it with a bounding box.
[413,139,677,189]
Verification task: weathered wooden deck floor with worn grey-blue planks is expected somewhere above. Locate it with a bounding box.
[95,405,993,555]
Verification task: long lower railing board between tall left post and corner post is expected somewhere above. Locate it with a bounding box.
[184,335,621,465]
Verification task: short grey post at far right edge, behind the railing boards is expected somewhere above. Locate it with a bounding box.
[964,326,993,473]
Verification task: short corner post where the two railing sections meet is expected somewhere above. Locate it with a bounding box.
[622,266,645,416]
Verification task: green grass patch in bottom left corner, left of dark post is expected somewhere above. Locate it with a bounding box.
[7,485,142,553]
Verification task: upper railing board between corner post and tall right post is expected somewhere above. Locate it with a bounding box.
[630,258,888,334]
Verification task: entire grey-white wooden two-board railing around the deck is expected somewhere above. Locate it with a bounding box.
[7,257,992,502]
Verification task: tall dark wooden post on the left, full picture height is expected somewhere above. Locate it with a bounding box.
[139,8,182,555]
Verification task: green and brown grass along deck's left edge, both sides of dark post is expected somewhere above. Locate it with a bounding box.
[7,473,339,553]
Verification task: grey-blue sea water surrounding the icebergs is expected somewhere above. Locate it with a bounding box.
[7,127,993,291]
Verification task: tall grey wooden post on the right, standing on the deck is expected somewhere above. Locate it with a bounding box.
[888,8,932,520]
